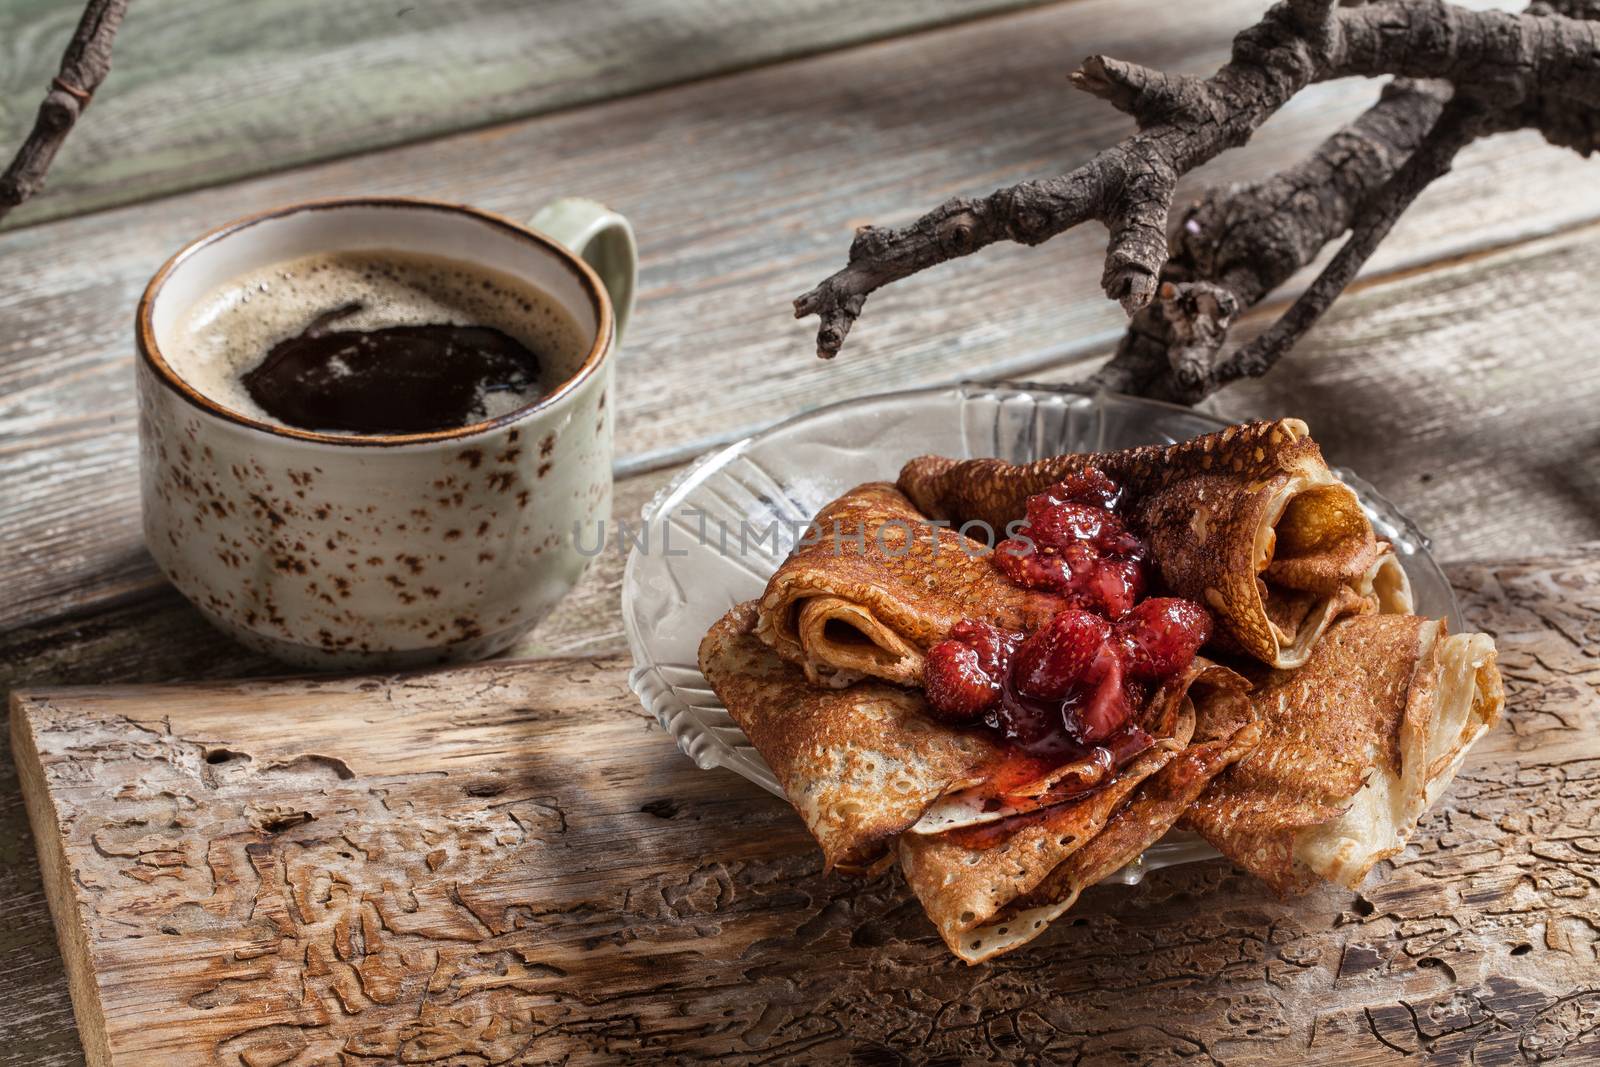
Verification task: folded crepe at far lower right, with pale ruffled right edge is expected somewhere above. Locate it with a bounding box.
[1184,614,1506,893]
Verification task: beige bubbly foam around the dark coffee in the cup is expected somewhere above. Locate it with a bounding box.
[172,250,589,426]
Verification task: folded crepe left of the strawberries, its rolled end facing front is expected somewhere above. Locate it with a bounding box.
[757,482,1067,686]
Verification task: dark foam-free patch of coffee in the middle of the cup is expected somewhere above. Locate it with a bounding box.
[243,304,542,434]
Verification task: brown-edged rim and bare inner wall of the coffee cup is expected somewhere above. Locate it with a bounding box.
[134,197,616,448]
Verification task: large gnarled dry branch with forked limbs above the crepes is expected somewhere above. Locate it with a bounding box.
[795,0,1600,403]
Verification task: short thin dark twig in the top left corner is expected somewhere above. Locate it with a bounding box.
[0,0,128,219]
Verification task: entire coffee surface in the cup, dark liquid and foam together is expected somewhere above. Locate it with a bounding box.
[166,250,587,434]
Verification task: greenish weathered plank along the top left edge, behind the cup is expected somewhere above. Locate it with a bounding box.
[0,0,1038,226]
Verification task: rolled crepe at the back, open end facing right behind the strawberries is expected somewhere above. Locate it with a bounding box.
[899,419,1411,667]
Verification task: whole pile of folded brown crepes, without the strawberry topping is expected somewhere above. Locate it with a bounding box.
[699,419,1504,963]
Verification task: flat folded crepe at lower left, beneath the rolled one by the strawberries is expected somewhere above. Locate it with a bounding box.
[699,603,1005,867]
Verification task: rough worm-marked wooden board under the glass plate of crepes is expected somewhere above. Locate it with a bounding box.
[11,549,1600,1067]
